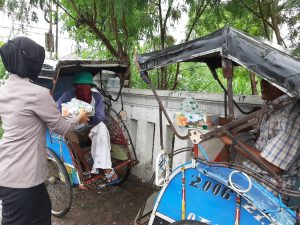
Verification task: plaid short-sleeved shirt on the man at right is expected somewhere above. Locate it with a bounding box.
[243,97,300,189]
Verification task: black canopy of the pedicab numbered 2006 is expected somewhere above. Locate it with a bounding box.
[137,26,300,96]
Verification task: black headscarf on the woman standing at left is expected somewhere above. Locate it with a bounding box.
[0,37,45,80]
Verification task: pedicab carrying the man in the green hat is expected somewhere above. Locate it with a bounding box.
[37,60,138,217]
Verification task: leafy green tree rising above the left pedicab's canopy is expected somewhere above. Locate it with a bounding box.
[1,0,149,85]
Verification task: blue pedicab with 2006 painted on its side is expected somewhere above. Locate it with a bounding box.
[135,27,300,225]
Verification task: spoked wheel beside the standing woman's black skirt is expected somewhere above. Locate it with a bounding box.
[46,148,72,217]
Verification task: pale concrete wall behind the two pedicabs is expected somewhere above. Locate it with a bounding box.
[108,88,262,181]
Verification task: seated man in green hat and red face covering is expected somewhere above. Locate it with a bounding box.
[57,71,118,184]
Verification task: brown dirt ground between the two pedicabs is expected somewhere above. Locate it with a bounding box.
[52,175,148,225]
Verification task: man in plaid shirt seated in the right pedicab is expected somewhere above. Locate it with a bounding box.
[222,80,300,200]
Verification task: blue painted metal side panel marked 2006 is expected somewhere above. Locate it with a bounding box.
[149,163,296,225]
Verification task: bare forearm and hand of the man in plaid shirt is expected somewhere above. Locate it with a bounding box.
[221,136,283,175]
